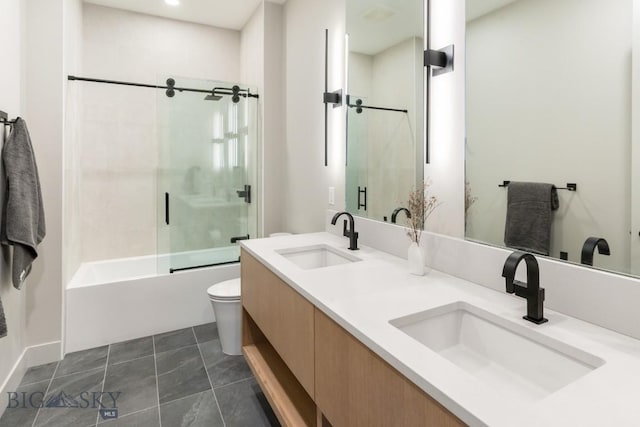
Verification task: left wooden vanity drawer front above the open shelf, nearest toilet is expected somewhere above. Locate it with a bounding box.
[240,250,315,398]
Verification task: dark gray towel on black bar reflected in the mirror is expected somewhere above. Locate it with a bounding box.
[504,182,560,255]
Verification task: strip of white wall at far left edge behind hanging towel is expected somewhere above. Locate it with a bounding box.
[0,0,27,414]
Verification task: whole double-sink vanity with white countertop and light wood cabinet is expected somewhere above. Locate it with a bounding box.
[241,233,640,427]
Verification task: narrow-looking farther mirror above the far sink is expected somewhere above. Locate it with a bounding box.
[345,0,424,224]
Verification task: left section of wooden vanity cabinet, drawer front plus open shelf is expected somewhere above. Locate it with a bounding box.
[240,250,316,426]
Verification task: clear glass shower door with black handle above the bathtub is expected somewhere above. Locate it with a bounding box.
[158,78,257,272]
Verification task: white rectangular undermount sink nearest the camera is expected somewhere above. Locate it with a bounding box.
[389,301,604,402]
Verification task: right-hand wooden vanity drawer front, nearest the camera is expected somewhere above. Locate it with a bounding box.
[315,309,465,427]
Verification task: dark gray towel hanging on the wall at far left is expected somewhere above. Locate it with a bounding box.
[0,117,46,289]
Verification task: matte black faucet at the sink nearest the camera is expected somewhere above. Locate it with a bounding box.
[502,251,547,325]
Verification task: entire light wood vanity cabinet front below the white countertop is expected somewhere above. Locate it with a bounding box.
[241,250,464,427]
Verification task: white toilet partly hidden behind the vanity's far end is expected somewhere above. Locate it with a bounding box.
[207,233,291,356]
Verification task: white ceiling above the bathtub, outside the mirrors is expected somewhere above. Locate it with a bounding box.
[84,0,286,30]
